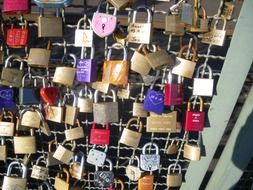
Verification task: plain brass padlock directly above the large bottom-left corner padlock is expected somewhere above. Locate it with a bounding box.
[13,129,37,154]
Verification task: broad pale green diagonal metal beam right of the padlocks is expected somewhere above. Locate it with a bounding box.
[180,0,253,190]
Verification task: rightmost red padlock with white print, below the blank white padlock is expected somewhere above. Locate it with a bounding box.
[185,96,205,132]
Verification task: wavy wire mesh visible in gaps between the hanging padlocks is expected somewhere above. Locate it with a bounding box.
[0,0,240,190]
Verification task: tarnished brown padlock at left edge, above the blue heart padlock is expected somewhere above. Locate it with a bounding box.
[1,54,24,88]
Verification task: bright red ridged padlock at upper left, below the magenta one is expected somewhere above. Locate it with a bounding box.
[6,20,28,48]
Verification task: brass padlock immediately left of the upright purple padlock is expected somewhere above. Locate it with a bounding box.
[53,53,76,86]
